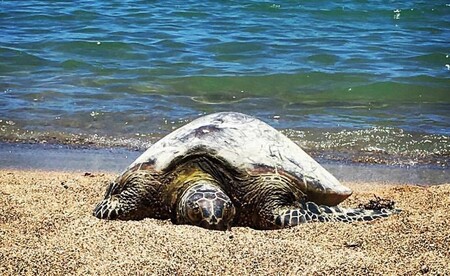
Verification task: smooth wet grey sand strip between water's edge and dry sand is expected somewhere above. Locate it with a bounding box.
[0,142,450,185]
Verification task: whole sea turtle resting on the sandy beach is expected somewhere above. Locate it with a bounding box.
[94,112,393,230]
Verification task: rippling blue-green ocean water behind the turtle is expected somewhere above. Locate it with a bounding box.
[0,0,450,169]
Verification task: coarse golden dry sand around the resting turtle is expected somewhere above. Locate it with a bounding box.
[0,170,450,275]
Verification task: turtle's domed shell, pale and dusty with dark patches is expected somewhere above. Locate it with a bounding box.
[123,112,352,205]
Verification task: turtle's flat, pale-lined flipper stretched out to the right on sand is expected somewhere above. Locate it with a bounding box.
[274,202,400,228]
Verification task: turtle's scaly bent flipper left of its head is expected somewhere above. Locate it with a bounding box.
[93,171,168,220]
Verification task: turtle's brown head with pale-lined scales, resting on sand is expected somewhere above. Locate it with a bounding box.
[177,180,236,230]
